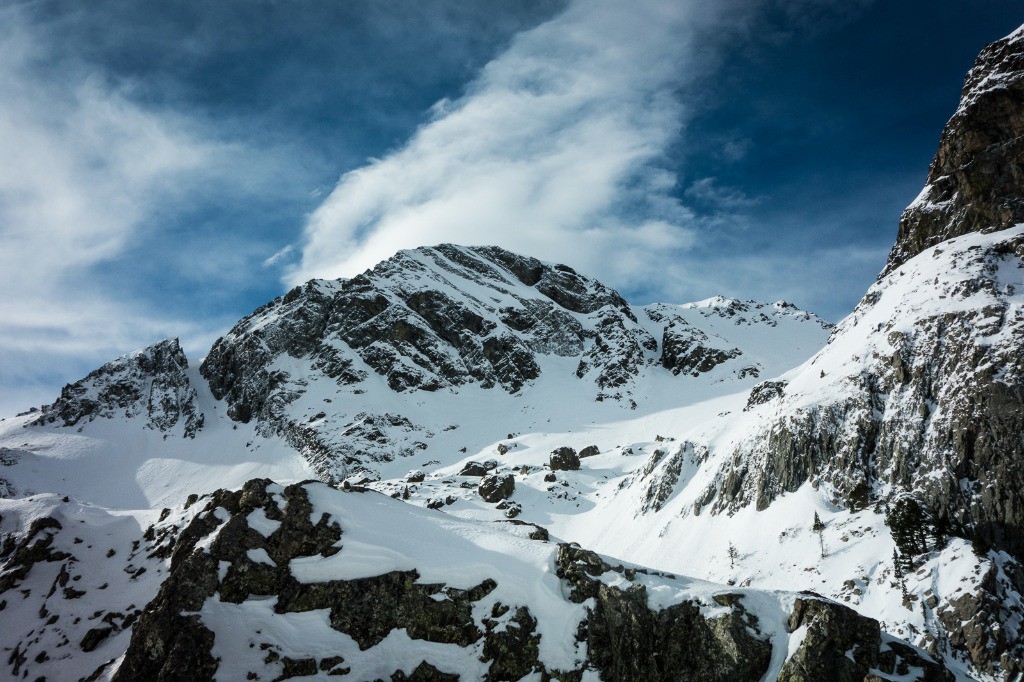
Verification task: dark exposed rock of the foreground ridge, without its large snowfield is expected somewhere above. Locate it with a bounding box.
[103,480,947,682]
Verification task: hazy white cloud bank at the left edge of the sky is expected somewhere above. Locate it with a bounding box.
[0,9,235,407]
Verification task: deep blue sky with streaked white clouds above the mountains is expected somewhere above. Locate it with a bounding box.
[0,0,1024,414]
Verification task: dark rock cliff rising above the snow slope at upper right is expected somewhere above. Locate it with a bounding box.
[882,25,1024,276]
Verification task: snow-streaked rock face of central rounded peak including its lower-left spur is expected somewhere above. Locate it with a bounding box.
[201,245,657,478]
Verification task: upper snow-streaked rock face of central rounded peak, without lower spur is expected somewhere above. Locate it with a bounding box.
[203,245,642,401]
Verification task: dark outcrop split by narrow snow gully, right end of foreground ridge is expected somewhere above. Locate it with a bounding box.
[555,544,953,682]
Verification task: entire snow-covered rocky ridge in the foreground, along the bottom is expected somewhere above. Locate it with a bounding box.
[0,480,953,682]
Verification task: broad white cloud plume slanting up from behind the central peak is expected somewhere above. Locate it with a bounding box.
[288,0,743,286]
